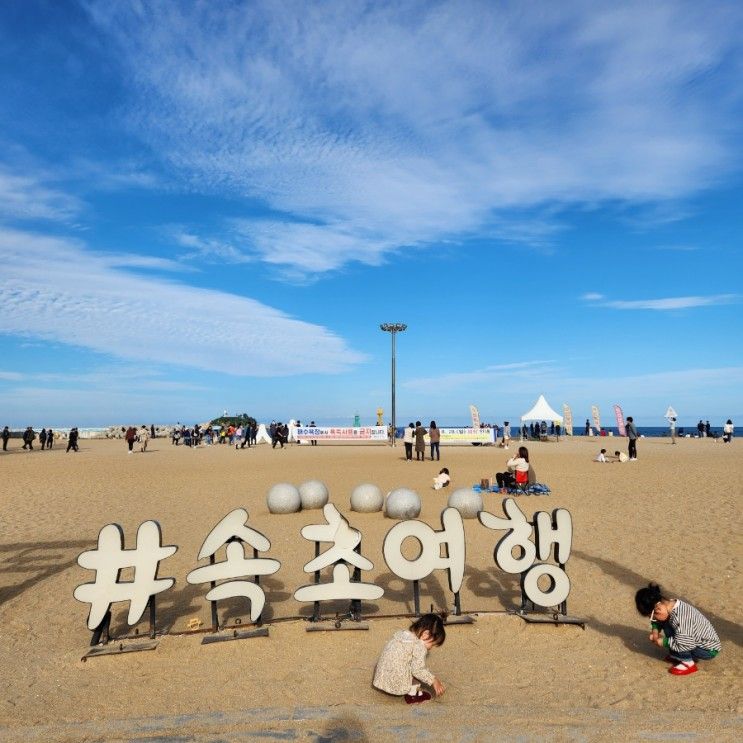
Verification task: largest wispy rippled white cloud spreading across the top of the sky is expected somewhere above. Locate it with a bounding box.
[80,0,740,273]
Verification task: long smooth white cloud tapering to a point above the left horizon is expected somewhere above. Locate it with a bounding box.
[0,230,363,376]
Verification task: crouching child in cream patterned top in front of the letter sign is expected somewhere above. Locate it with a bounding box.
[372,614,446,704]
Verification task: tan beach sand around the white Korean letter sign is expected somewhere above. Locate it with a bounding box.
[0,438,743,741]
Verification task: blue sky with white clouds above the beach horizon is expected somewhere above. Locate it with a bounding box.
[0,0,743,426]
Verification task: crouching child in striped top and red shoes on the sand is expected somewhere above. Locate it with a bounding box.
[635,583,722,676]
